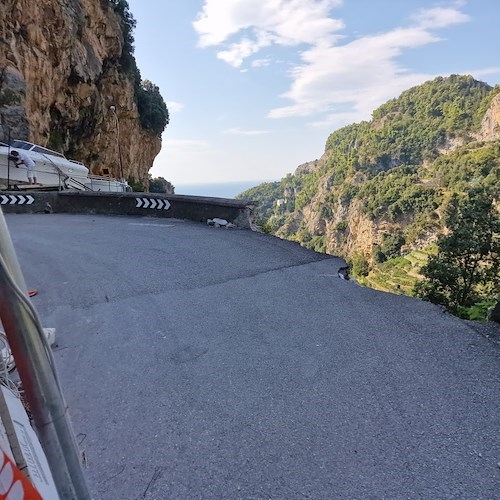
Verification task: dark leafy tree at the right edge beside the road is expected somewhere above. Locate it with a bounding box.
[415,188,500,315]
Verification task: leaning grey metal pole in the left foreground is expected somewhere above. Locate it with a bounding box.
[0,208,90,500]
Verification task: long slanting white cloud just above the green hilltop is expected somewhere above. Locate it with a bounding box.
[269,3,468,122]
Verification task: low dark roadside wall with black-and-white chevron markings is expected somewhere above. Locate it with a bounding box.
[0,191,255,229]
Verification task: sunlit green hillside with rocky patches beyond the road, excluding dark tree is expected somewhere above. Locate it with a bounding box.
[239,75,500,320]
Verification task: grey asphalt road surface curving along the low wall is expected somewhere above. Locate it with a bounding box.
[6,214,500,500]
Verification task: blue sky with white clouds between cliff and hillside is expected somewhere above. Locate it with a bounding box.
[128,0,500,185]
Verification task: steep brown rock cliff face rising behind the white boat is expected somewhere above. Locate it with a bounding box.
[0,0,161,182]
